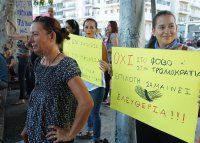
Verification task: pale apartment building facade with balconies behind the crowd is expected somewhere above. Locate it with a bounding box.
[34,0,200,40]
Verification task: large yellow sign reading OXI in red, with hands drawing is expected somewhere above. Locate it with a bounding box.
[111,47,200,143]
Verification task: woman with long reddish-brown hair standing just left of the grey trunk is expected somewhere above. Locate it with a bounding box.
[103,21,118,106]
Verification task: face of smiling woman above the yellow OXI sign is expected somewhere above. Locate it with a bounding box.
[153,15,177,48]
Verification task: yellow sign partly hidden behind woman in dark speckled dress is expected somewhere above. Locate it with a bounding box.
[63,34,102,86]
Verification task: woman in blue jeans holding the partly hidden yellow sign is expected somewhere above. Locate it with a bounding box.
[77,18,108,143]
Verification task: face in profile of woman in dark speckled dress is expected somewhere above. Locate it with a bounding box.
[29,22,52,55]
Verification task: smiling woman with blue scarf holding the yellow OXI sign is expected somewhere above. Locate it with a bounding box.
[136,10,199,143]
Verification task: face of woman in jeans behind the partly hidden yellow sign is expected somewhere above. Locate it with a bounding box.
[84,20,97,38]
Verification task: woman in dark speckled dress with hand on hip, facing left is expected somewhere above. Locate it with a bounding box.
[21,16,93,143]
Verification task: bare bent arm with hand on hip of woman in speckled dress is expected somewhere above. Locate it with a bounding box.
[47,76,94,143]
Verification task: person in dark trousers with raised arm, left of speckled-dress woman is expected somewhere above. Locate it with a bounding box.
[6,20,33,105]
